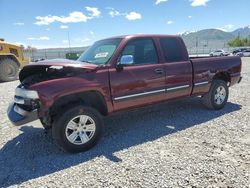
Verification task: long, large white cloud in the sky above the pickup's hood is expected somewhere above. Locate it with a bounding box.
[34,7,101,25]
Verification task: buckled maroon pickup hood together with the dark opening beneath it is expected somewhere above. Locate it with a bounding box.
[19,59,98,82]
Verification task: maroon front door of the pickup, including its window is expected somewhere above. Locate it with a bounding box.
[110,38,165,110]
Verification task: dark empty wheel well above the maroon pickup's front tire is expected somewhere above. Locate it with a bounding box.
[50,91,108,116]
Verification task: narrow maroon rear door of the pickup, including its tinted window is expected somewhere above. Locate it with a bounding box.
[159,37,192,99]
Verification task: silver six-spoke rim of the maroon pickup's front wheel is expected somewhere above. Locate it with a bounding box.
[65,115,96,145]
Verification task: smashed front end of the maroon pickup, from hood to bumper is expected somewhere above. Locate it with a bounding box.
[8,59,94,126]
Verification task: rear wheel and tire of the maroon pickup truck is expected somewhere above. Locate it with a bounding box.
[202,80,229,110]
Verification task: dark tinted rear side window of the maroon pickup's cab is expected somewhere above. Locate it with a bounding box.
[160,37,185,62]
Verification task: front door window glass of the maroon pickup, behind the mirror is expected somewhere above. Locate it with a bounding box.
[122,39,158,65]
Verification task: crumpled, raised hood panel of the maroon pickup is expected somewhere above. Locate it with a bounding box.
[19,59,98,82]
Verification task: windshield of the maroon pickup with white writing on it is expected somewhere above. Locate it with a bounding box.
[78,38,122,65]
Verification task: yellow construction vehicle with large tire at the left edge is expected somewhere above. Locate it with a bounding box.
[0,39,30,82]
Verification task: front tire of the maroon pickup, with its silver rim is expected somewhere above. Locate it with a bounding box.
[52,105,103,153]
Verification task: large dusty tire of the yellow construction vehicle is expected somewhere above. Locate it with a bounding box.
[0,58,19,82]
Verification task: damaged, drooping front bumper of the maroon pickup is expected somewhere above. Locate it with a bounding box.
[7,103,38,126]
